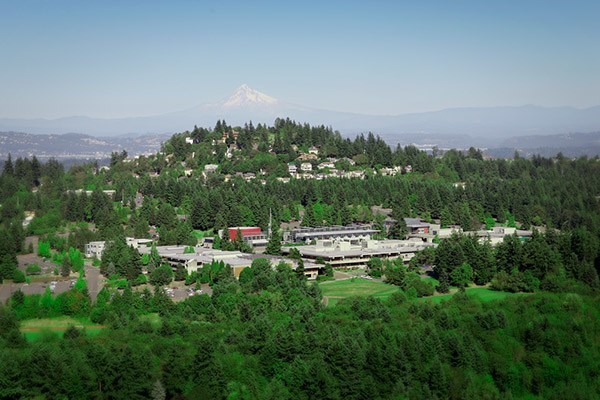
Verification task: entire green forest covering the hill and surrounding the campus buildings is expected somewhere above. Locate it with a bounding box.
[0,119,600,399]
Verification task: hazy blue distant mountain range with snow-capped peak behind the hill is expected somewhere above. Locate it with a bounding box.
[0,85,600,153]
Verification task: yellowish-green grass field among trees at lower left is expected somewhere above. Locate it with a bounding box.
[21,317,104,342]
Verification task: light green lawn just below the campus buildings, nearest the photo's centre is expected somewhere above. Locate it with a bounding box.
[319,278,399,305]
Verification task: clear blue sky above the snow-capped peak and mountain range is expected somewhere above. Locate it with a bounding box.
[0,0,600,118]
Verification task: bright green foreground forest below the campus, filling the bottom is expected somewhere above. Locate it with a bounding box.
[0,261,600,399]
